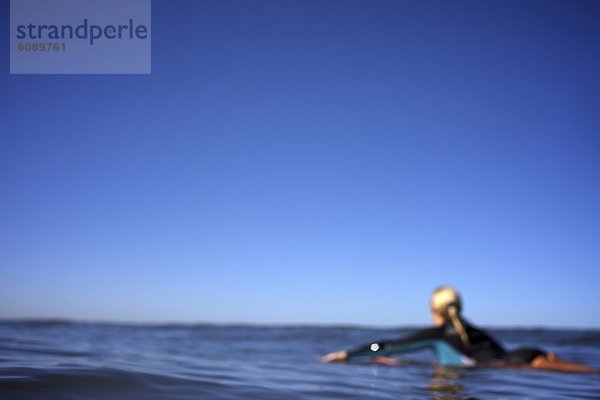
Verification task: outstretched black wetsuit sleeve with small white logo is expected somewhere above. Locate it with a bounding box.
[348,328,444,360]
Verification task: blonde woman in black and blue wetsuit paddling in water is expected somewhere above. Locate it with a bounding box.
[323,286,595,372]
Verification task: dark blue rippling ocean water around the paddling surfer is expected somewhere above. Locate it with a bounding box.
[0,321,600,400]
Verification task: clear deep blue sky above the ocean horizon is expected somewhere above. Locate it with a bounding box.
[0,0,600,327]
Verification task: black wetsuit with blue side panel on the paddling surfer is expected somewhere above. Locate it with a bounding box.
[348,323,545,365]
